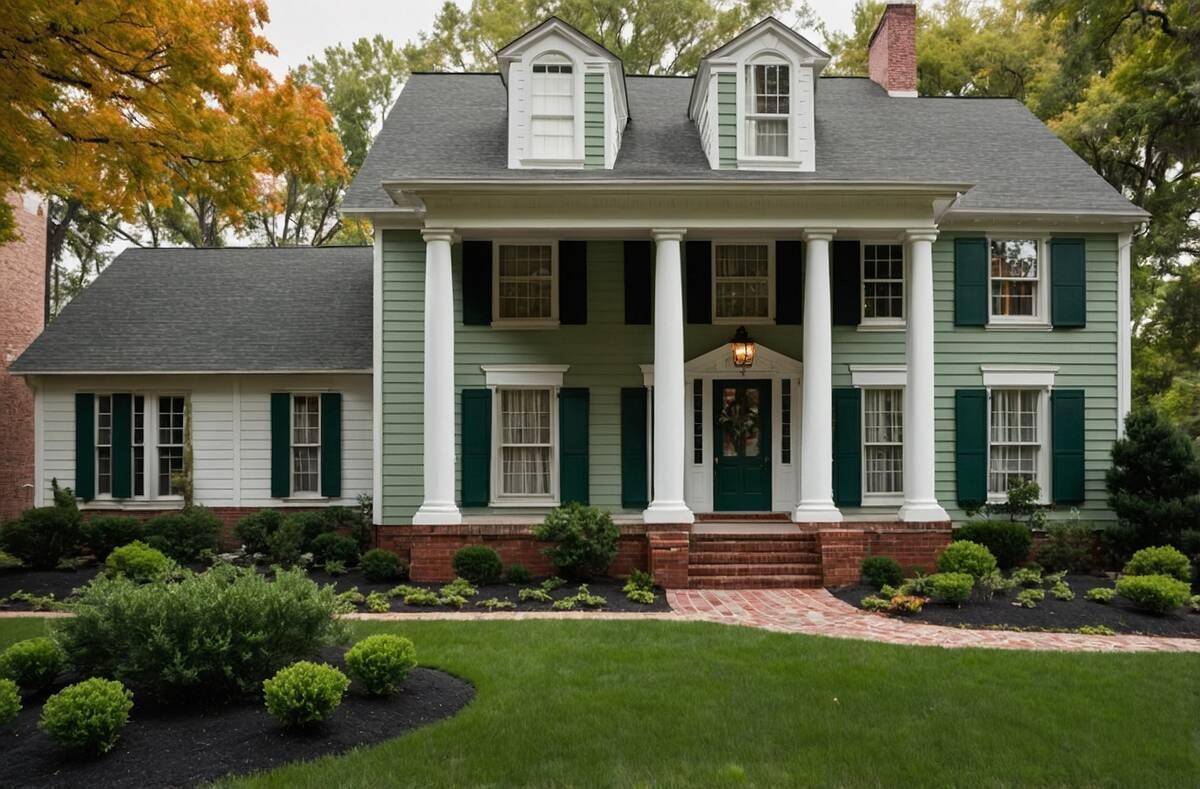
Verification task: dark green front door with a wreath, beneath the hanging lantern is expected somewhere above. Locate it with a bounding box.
[713,380,770,512]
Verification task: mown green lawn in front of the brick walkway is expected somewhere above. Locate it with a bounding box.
[0,620,1200,789]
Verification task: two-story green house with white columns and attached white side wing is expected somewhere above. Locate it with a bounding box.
[14,4,1147,586]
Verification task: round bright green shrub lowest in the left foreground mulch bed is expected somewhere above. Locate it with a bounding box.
[38,677,133,753]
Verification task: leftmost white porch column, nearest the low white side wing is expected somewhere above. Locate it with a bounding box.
[417,229,462,525]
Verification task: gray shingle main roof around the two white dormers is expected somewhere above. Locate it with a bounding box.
[343,74,1138,212]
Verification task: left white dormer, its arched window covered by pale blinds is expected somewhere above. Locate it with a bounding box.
[497,17,629,169]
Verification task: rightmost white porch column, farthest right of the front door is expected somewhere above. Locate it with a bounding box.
[900,230,949,523]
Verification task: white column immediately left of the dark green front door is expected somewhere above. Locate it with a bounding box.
[643,229,694,524]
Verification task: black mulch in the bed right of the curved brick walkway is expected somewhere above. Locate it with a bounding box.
[832,576,1200,638]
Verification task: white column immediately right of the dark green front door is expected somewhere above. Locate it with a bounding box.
[780,229,841,523]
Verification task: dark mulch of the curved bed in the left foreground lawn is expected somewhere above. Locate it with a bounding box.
[0,650,475,787]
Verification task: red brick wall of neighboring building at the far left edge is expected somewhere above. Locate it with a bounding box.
[0,195,46,522]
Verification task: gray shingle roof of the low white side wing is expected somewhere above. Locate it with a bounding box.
[10,247,372,373]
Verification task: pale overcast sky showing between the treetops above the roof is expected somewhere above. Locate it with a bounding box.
[266,0,853,74]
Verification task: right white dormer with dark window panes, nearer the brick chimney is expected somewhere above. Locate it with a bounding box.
[688,17,829,171]
